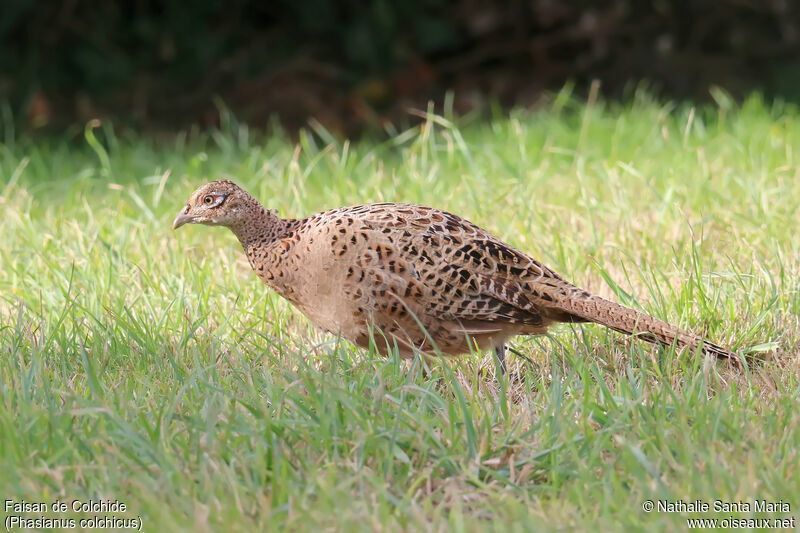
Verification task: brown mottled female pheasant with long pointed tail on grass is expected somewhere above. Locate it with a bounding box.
[173,180,739,364]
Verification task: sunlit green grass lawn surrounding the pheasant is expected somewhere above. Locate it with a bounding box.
[0,92,800,531]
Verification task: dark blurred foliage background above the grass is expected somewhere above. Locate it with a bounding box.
[0,0,800,134]
